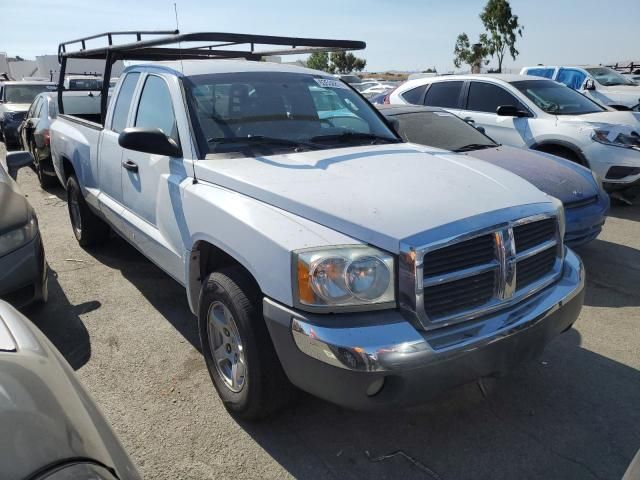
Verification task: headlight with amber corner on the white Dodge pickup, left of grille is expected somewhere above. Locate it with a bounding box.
[293,246,395,311]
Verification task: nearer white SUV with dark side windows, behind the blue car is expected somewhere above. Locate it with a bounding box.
[389,74,640,190]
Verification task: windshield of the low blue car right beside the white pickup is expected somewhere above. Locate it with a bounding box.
[390,111,497,151]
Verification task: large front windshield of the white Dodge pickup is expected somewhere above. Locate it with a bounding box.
[185,72,399,153]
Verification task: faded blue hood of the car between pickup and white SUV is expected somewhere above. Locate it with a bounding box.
[463,145,598,203]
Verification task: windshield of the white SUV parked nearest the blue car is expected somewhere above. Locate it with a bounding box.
[512,80,605,115]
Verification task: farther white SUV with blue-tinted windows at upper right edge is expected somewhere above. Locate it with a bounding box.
[520,66,640,111]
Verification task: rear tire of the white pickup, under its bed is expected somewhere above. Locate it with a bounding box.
[67,175,110,248]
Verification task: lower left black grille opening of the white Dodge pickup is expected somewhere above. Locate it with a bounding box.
[424,271,495,318]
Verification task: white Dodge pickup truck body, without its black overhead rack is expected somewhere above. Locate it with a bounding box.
[51,31,584,418]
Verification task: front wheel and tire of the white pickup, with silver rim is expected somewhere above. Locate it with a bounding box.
[198,266,295,420]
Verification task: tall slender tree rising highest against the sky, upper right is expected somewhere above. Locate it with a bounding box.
[480,0,524,72]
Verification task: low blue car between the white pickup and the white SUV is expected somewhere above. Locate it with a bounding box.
[378,105,609,247]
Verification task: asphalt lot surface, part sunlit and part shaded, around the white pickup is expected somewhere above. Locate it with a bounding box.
[0,143,640,480]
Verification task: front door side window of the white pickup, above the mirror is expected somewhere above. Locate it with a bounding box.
[135,75,179,143]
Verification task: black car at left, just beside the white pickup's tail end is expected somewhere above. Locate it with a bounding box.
[19,93,58,188]
